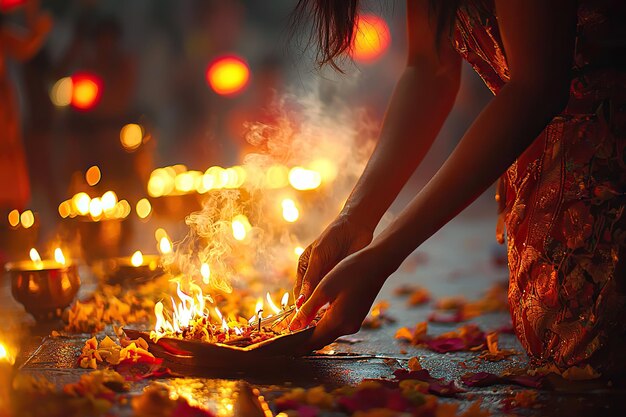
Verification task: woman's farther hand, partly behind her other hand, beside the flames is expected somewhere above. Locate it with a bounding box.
[294,214,373,308]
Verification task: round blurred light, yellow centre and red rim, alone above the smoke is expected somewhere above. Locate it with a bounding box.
[206,56,250,96]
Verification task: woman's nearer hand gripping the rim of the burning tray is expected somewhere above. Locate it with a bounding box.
[289,247,394,352]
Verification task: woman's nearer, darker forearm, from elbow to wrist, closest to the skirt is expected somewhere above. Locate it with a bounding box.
[372,81,567,267]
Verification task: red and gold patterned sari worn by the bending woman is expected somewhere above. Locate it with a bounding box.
[453,0,626,370]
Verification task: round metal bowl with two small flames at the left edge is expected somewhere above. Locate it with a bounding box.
[6,261,80,321]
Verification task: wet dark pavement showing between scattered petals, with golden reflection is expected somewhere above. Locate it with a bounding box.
[0,195,626,416]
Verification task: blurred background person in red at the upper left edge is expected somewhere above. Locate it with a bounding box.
[0,0,52,212]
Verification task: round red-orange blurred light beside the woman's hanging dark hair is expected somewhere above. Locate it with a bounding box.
[351,14,391,63]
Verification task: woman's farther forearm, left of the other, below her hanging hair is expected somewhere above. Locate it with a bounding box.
[342,63,460,231]
